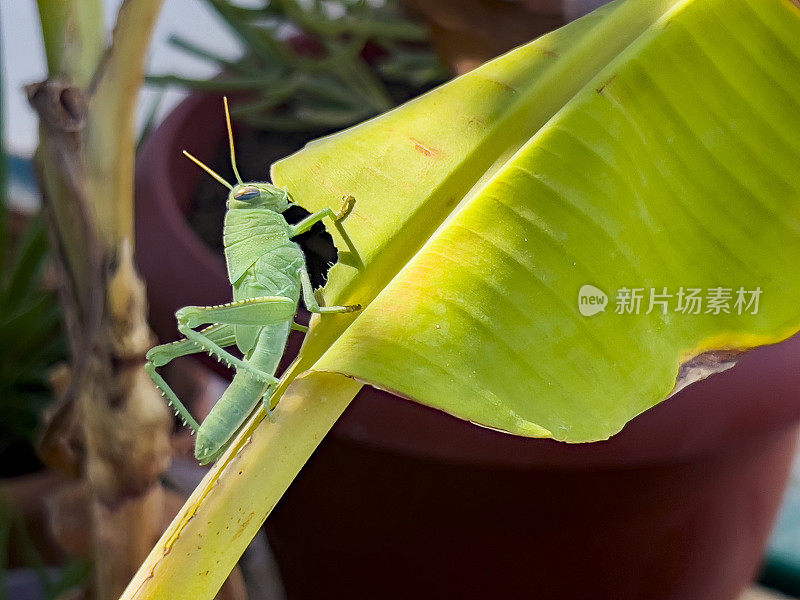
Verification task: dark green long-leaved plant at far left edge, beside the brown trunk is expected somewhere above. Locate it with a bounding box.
[0,24,91,600]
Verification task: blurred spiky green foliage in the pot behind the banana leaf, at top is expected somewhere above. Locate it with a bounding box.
[148,0,447,131]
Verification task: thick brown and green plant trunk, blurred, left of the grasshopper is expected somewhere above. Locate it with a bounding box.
[19,0,171,600]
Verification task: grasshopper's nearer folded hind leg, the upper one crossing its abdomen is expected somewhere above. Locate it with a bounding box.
[175,296,297,383]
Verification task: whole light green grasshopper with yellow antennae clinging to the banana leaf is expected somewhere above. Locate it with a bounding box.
[145,99,361,464]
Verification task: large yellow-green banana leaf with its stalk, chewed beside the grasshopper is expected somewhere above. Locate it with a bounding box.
[126,0,800,598]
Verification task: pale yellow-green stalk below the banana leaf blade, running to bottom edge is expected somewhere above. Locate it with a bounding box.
[120,373,361,600]
